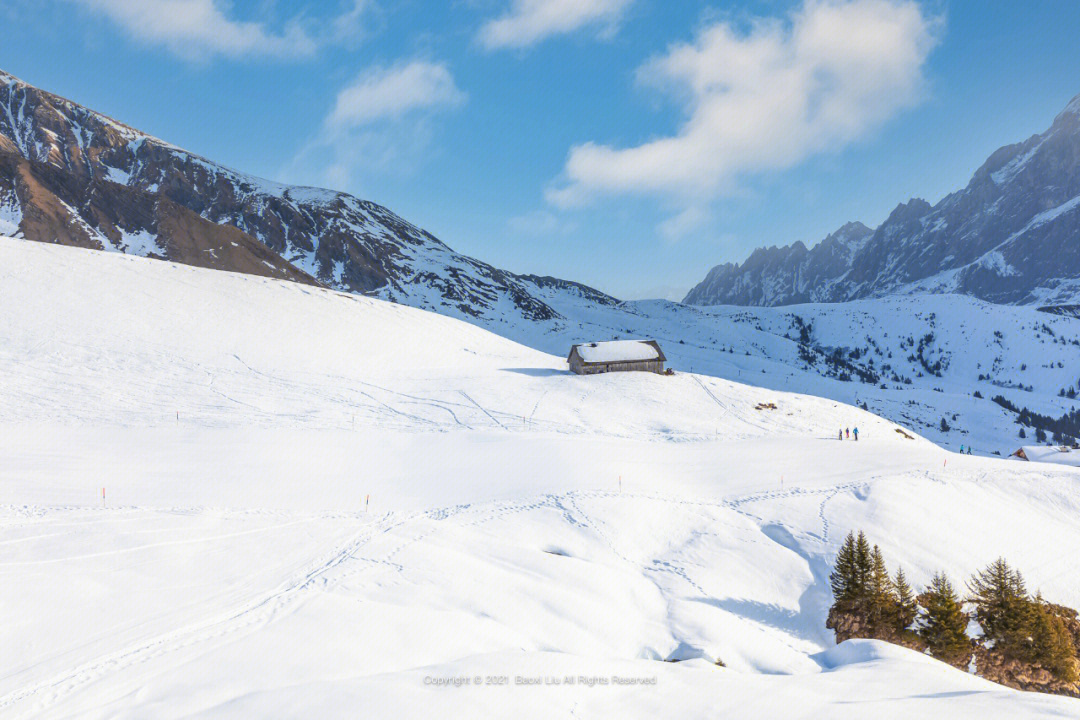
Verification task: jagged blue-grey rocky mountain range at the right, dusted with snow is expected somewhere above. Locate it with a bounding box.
[685,95,1080,305]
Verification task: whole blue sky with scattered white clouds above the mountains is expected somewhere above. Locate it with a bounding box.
[0,0,1080,298]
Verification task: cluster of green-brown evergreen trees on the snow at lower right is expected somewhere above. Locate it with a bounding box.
[825,531,1080,696]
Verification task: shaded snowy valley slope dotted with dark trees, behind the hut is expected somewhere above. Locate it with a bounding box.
[473,284,1080,456]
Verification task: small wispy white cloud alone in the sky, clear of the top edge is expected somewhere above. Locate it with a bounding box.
[325,60,465,131]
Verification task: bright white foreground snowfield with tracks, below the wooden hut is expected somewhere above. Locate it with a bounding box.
[0,240,1080,718]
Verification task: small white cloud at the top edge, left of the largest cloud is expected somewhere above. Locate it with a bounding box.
[476,0,633,50]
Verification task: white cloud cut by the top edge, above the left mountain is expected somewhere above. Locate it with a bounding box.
[69,0,369,59]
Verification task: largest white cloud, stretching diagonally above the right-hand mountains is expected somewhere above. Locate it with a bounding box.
[546,0,940,223]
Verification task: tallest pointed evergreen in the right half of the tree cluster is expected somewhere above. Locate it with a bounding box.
[968,558,1031,656]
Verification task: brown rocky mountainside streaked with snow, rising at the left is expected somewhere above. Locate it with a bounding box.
[0,72,617,321]
